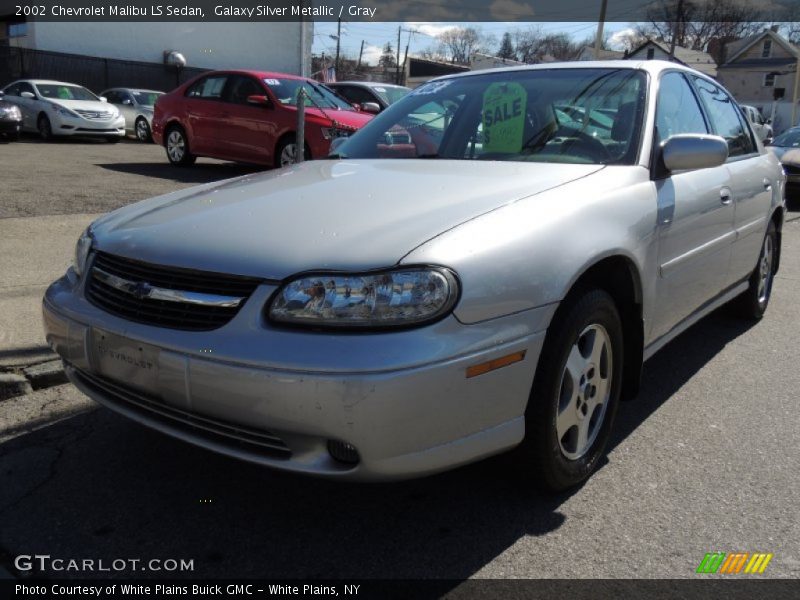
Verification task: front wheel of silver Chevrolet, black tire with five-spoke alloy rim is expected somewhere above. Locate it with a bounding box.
[521,289,624,492]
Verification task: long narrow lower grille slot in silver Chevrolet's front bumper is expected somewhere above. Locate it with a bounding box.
[68,365,292,459]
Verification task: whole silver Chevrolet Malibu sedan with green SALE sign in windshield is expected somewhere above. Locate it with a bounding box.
[44,61,785,490]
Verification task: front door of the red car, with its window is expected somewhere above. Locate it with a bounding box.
[220,75,277,164]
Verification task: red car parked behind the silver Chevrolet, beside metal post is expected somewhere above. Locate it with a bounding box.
[153,71,372,167]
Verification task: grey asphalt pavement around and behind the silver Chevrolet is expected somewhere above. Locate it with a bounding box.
[0,139,800,580]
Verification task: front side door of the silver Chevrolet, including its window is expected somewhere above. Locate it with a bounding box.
[650,71,735,339]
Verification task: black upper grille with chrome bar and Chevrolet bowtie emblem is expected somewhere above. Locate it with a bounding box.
[86,252,261,331]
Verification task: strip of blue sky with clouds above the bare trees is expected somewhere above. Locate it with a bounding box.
[313,21,633,64]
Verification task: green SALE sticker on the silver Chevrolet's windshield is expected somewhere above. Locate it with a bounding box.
[483,83,528,152]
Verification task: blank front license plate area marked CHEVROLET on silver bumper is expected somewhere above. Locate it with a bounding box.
[92,329,159,392]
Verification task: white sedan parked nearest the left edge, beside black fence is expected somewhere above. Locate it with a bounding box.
[3,79,125,142]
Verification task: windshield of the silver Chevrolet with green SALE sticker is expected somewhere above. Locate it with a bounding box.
[335,68,647,164]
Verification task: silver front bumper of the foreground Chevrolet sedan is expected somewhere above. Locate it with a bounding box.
[43,275,555,480]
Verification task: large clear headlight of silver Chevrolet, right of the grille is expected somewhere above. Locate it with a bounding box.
[268,267,458,329]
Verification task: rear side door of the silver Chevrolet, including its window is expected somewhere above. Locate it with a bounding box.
[694,77,776,285]
